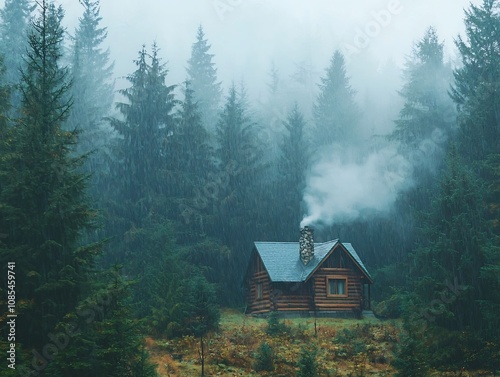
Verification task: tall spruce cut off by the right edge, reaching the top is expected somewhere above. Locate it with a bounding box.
[452,0,500,350]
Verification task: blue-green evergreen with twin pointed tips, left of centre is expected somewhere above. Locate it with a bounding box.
[110,44,176,222]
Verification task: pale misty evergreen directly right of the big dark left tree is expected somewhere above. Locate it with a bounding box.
[67,0,114,176]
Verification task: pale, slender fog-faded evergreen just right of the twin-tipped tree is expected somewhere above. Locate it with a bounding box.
[187,25,222,131]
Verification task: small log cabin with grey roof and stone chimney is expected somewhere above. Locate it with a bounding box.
[245,227,373,317]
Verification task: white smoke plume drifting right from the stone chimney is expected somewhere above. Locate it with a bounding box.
[300,131,444,227]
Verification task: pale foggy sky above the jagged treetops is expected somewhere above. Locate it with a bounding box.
[53,0,477,98]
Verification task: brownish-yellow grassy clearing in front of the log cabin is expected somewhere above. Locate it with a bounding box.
[146,310,493,377]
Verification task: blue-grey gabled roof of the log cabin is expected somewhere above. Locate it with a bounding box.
[254,240,371,283]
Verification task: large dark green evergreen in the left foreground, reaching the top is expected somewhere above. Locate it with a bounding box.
[0,1,100,347]
